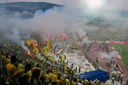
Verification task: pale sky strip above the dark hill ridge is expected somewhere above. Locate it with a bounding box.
[0,0,128,10]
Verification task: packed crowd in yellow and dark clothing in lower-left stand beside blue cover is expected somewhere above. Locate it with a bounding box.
[0,39,106,85]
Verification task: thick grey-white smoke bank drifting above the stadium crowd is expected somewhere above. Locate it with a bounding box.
[0,2,128,40]
